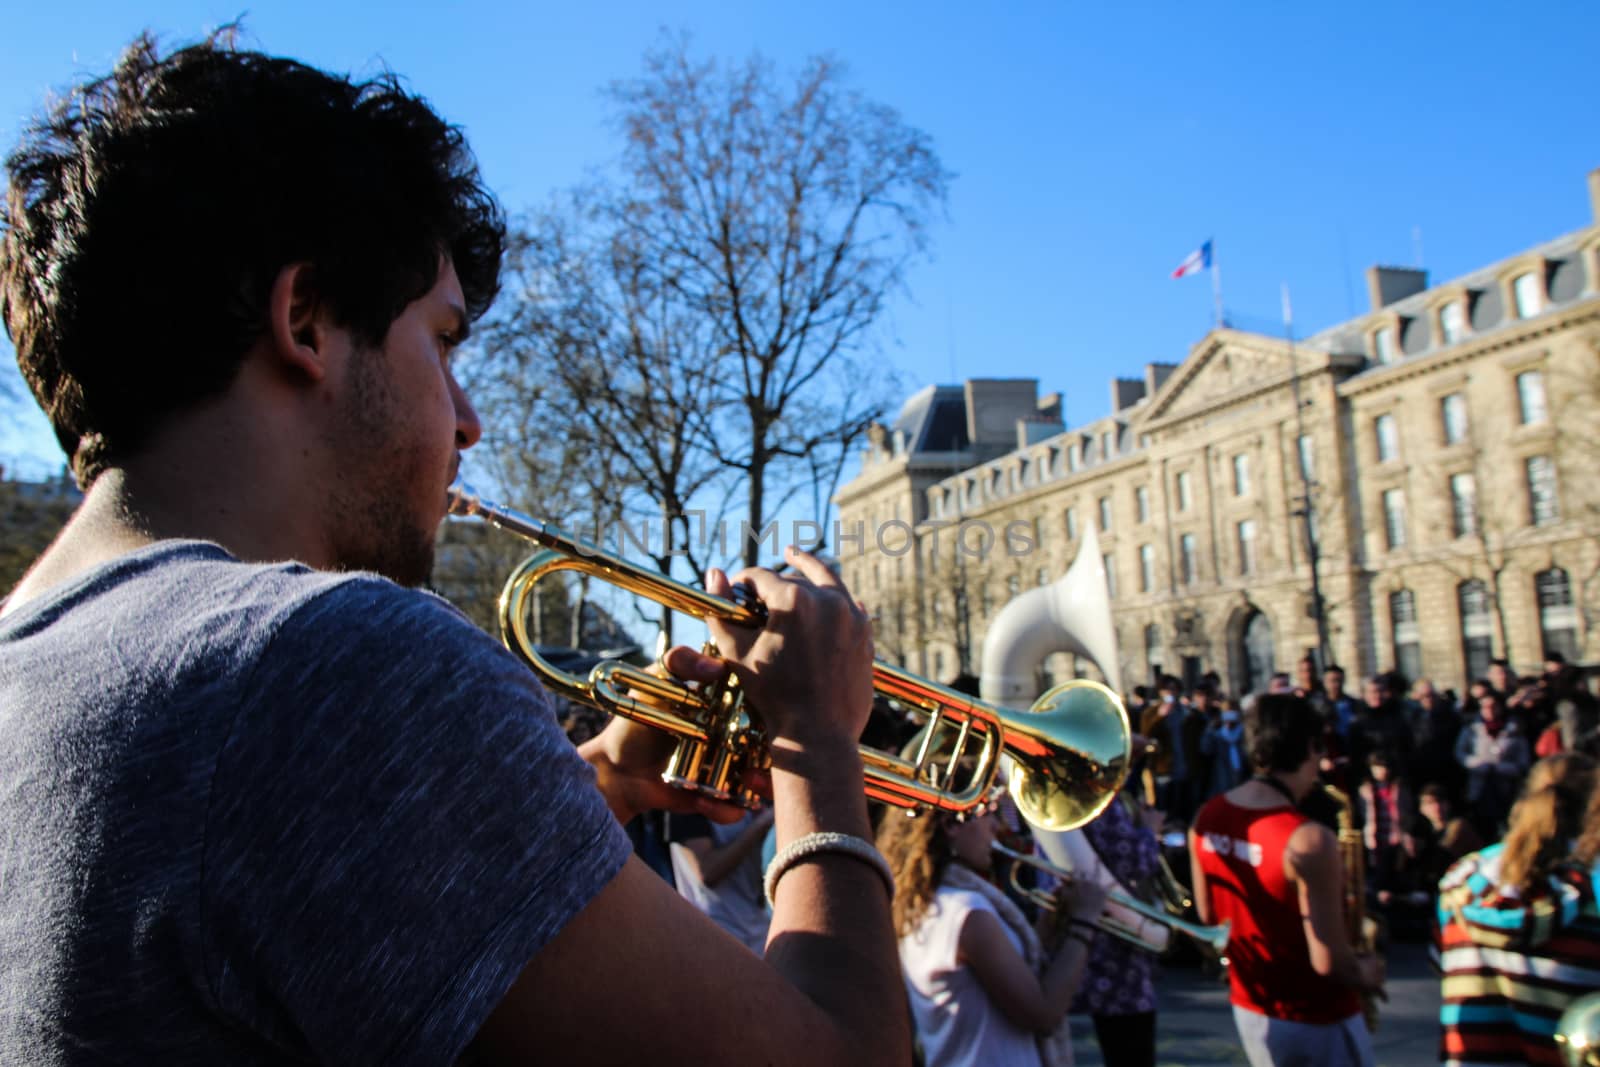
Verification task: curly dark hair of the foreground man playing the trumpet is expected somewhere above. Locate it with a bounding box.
[0,27,506,488]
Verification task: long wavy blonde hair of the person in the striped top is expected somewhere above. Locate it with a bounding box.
[1501,752,1600,889]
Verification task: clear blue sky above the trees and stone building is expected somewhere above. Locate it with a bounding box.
[0,0,1600,474]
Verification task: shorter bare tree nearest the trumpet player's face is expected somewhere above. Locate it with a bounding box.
[475,203,726,638]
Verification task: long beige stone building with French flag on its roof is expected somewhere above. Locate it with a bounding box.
[837,170,1600,693]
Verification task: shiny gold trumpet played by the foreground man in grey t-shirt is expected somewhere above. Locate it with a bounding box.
[448,482,1130,829]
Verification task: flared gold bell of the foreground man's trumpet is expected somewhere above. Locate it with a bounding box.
[1005,678,1131,830]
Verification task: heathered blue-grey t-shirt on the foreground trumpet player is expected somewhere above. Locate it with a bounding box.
[0,542,629,1065]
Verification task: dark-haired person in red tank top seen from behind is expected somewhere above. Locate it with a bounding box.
[1189,694,1384,1067]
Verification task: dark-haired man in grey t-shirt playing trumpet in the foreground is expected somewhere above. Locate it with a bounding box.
[0,29,910,1065]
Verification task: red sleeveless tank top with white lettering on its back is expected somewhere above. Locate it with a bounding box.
[1194,795,1362,1024]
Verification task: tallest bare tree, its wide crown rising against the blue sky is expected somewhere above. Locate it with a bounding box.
[610,38,949,565]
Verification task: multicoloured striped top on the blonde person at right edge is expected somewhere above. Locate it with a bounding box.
[1438,845,1600,1067]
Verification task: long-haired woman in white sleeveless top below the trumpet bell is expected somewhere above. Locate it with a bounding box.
[878,805,1106,1067]
